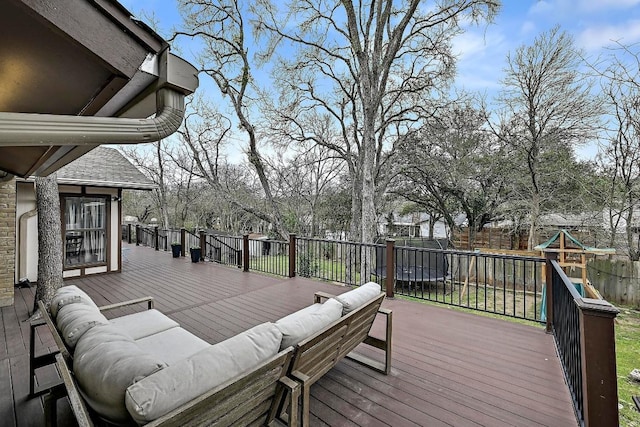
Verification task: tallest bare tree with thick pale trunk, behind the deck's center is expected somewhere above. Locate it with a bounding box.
[255,0,498,246]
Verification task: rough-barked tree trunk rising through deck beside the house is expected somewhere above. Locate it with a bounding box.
[34,173,63,317]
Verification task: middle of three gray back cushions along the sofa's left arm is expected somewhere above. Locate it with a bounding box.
[56,304,109,349]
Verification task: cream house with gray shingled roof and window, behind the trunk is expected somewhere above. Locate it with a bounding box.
[10,147,155,283]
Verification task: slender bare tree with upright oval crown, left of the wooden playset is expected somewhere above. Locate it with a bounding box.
[495,27,599,250]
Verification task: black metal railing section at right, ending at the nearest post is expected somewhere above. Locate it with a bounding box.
[551,261,584,425]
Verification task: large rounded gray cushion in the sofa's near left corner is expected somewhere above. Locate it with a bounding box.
[73,325,166,423]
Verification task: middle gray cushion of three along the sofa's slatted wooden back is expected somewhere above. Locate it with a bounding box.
[276,298,343,350]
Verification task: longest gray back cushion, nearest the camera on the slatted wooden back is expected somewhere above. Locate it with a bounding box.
[126,323,282,424]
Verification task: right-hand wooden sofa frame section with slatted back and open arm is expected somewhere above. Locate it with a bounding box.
[289,292,393,427]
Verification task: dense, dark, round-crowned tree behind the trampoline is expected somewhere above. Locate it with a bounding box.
[394,101,513,245]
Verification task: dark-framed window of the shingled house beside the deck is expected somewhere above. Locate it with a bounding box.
[63,196,107,267]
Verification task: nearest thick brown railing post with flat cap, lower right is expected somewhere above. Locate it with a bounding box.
[578,298,619,427]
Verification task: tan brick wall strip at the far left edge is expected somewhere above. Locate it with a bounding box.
[0,179,16,307]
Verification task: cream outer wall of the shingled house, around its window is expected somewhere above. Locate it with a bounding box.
[11,182,121,289]
